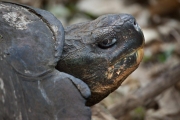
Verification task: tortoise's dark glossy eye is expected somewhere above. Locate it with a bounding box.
[98,38,117,49]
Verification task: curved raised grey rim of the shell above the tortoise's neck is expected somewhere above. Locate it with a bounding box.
[3,1,65,66]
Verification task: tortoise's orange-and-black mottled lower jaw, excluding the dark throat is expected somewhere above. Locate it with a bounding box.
[94,46,144,90]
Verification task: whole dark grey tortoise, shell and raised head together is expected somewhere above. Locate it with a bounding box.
[0,2,144,120]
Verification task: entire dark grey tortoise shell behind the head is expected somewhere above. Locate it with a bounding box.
[0,2,91,120]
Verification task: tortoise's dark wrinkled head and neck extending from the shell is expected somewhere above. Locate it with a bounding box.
[57,14,144,106]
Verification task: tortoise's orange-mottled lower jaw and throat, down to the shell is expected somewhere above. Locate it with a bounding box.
[87,46,144,106]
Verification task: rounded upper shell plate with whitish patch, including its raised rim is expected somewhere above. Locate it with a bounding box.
[0,2,64,77]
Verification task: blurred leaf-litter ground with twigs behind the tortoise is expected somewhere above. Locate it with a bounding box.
[4,0,180,120]
